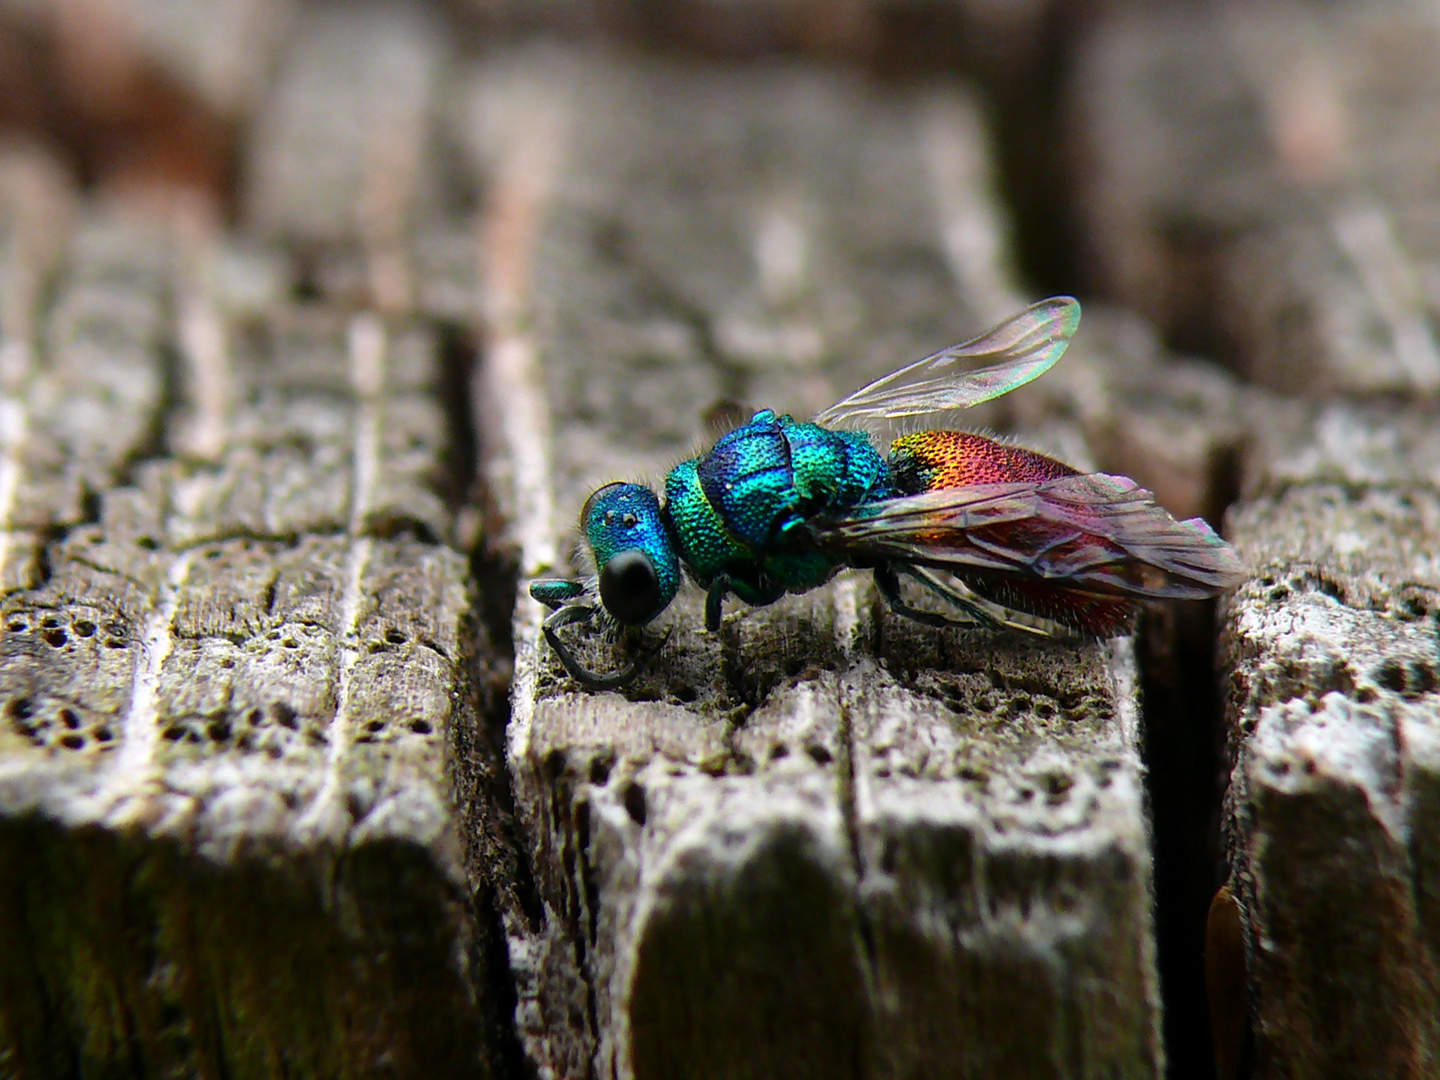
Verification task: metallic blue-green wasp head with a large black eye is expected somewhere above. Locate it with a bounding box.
[580,484,680,626]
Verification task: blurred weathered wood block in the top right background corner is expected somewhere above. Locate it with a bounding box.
[1070,1,1440,395]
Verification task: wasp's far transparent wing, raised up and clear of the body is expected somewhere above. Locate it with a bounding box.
[815,297,1080,428]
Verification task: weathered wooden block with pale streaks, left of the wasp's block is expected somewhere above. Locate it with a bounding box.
[0,197,508,1076]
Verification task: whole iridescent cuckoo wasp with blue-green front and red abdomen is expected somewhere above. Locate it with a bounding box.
[530,297,1241,690]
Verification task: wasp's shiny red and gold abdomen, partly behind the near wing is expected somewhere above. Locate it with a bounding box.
[890,431,1136,638]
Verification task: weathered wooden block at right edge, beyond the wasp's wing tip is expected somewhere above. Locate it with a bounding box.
[1221,405,1440,1077]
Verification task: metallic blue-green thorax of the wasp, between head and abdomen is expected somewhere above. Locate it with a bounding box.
[661,409,890,603]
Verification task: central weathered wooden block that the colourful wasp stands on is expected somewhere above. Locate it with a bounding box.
[472,52,1162,1076]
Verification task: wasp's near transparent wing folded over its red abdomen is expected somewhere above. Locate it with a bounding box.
[814,472,1243,599]
